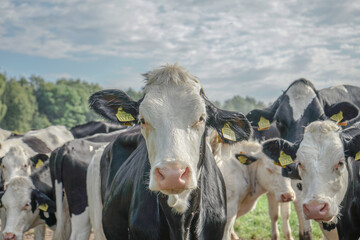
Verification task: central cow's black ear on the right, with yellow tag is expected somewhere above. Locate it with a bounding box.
[201,90,252,144]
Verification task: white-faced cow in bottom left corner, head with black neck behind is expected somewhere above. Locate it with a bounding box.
[0,162,56,240]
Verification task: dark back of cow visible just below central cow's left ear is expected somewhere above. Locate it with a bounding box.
[70,121,125,138]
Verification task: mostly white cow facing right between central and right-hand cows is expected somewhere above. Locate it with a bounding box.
[209,131,295,240]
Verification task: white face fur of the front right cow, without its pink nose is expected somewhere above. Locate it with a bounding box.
[297,121,349,223]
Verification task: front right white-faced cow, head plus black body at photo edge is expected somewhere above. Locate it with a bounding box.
[263,120,360,239]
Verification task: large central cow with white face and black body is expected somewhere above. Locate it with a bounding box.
[89,64,251,239]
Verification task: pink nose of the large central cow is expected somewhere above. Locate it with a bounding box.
[154,165,190,192]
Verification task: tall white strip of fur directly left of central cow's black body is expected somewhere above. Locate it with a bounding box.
[86,147,106,240]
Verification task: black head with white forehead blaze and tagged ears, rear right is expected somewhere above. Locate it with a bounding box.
[246,79,358,142]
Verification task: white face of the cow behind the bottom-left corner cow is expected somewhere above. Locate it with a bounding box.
[1,146,31,186]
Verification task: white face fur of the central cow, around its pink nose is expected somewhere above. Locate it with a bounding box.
[139,64,206,212]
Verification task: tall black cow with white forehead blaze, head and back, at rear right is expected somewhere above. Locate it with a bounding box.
[246,79,360,142]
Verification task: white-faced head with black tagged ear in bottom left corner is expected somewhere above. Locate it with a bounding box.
[1,176,56,240]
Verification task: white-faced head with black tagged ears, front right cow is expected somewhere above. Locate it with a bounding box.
[263,121,360,223]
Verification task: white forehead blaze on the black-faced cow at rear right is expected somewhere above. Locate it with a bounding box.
[286,82,316,121]
